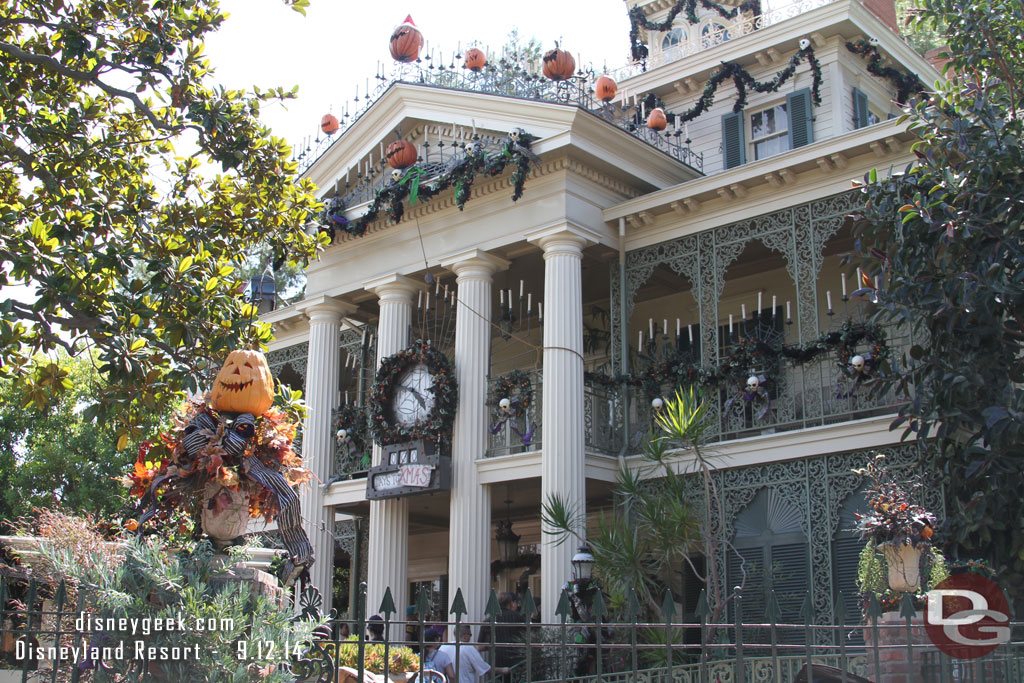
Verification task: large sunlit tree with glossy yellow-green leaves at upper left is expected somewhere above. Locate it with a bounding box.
[0,0,323,454]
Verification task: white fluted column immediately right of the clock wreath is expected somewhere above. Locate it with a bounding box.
[441,249,509,622]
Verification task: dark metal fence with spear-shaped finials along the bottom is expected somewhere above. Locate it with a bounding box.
[0,581,1024,683]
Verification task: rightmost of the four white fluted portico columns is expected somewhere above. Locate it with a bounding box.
[527,227,593,623]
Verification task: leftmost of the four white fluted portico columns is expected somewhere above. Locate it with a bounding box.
[300,296,355,604]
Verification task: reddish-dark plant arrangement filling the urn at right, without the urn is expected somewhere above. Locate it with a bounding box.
[853,454,936,548]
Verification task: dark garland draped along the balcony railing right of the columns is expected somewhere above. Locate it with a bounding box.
[584,321,889,398]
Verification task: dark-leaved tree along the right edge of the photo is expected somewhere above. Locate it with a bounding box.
[858,0,1024,598]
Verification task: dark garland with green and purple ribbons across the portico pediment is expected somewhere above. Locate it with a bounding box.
[318,131,538,244]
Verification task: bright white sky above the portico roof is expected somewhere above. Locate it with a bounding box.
[207,0,630,156]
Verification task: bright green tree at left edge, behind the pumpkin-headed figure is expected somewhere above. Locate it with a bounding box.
[0,354,149,519]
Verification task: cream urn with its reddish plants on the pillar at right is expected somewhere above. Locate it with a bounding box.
[854,454,935,593]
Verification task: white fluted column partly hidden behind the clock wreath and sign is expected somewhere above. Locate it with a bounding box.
[364,274,422,638]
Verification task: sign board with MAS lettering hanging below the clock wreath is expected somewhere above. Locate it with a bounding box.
[367,441,452,501]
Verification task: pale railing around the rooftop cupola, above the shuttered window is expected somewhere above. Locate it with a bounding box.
[609,0,836,81]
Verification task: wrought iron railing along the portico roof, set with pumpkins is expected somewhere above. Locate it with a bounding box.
[297,59,703,178]
